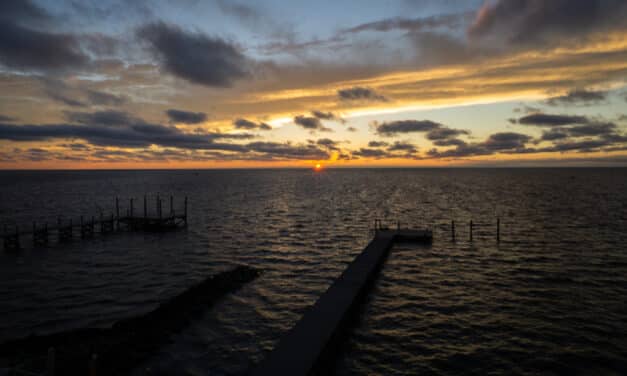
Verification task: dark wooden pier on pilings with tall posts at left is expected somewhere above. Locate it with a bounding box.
[2,196,187,251]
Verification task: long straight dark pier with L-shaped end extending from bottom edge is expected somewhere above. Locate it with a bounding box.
[252,228,432,376]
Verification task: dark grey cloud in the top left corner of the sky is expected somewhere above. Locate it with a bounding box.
[0,0,89,71]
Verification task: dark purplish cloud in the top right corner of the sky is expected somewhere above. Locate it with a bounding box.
[468,0,627,44]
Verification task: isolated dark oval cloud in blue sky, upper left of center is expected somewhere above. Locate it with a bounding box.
[138,22,248,87]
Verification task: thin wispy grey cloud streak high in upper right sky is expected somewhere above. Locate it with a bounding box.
[342,13,472,33]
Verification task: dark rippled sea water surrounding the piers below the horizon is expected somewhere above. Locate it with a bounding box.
[0,169,627,375]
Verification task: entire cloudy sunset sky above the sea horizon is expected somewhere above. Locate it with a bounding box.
[0,0,627,169]
